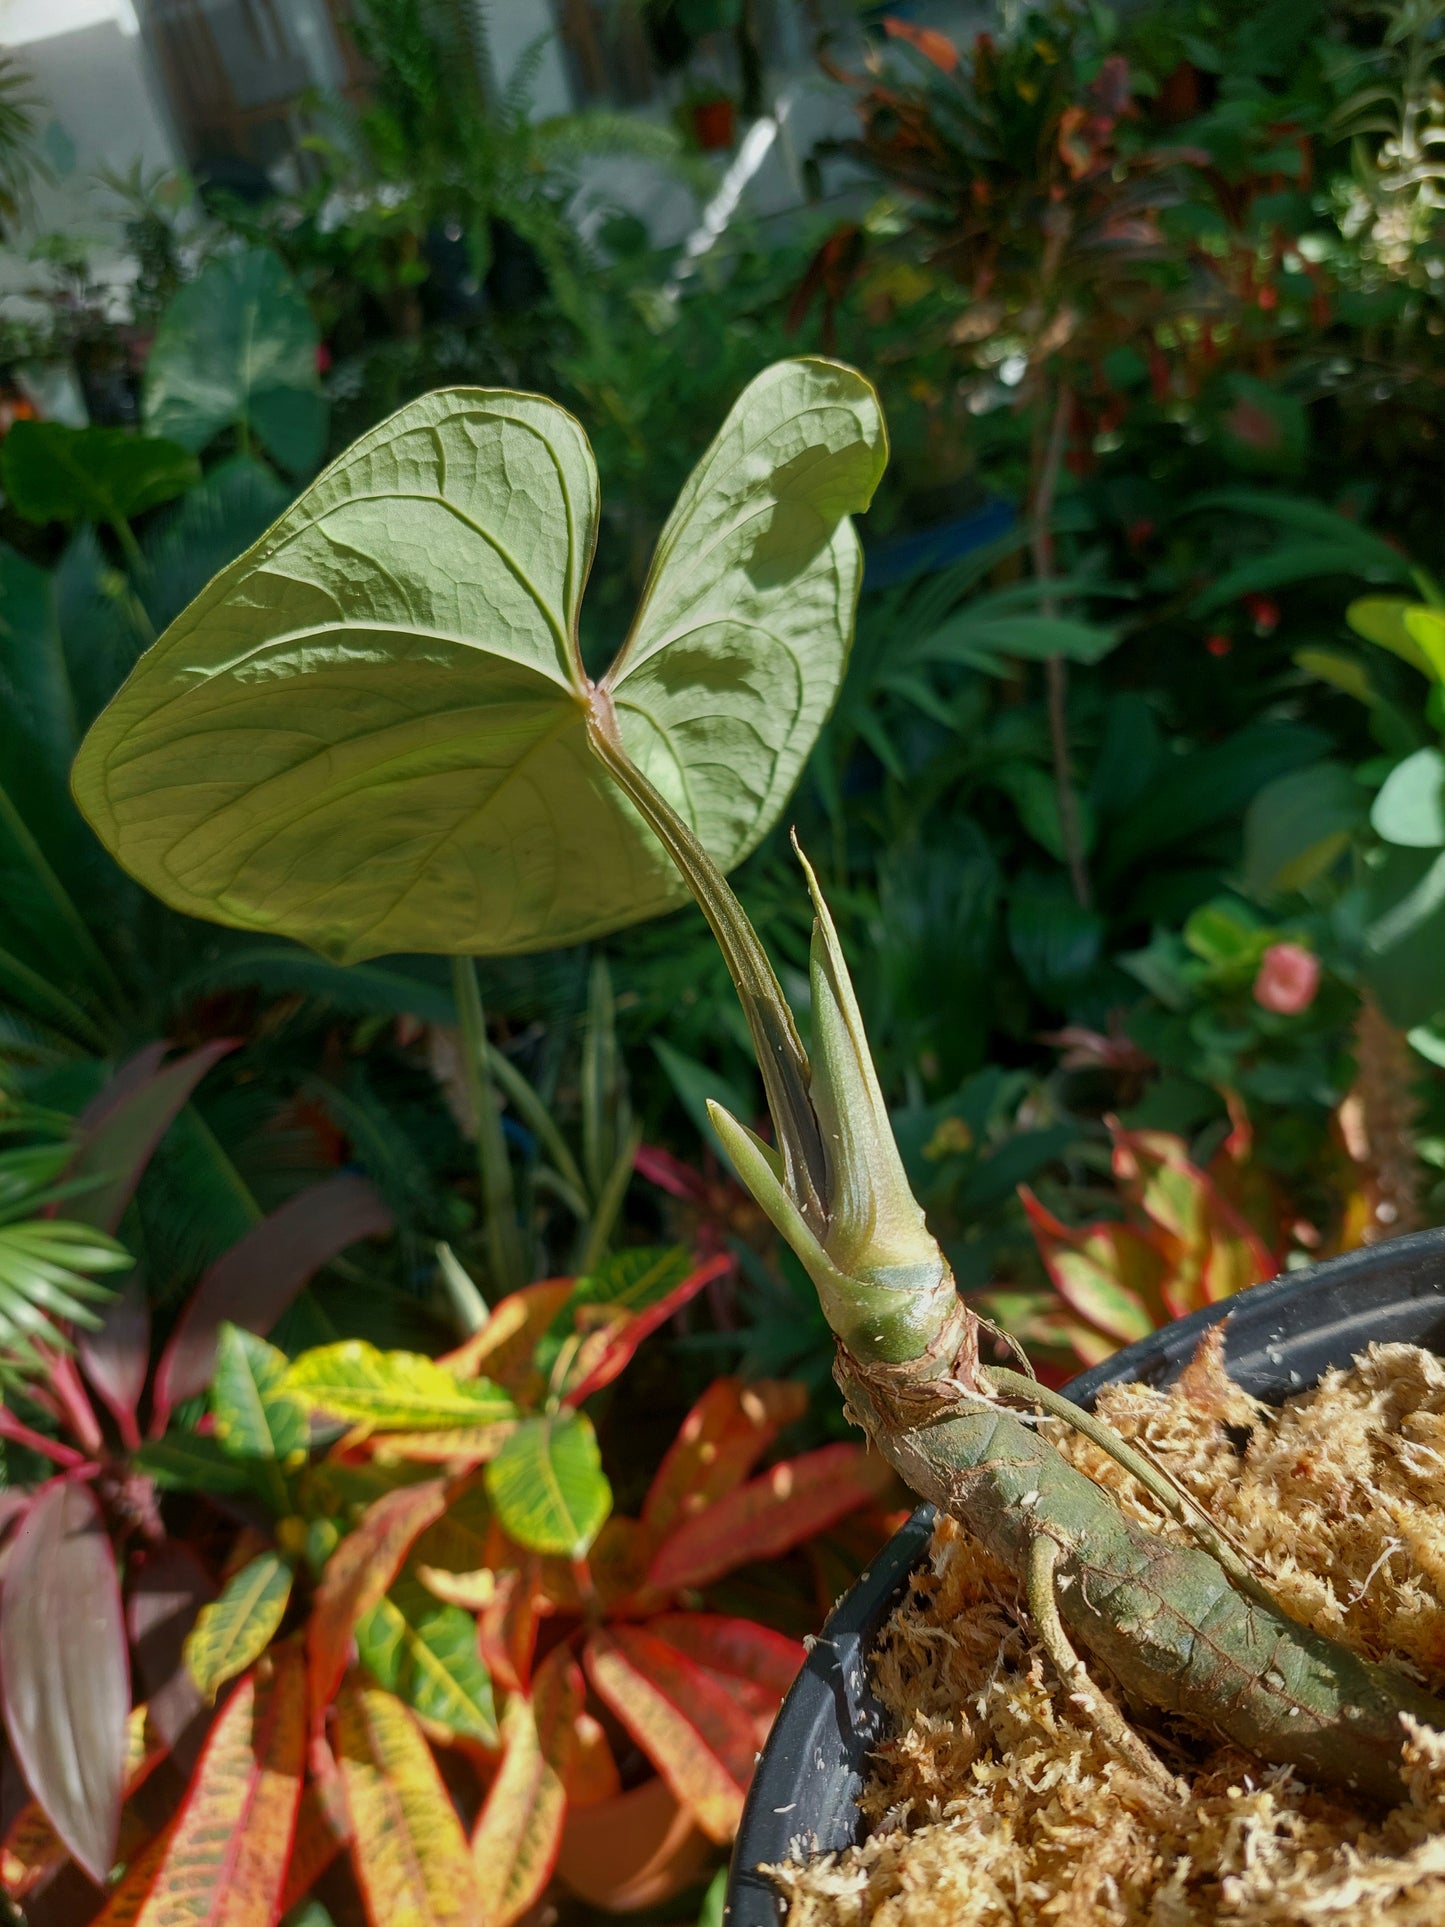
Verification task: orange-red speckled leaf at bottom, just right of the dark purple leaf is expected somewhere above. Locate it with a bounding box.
[135,1642,306,1927]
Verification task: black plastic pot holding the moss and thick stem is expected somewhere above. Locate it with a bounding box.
[724,1231,1445,1927]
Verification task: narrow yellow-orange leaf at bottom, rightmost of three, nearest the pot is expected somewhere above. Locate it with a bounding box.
[472,1646,586,1927]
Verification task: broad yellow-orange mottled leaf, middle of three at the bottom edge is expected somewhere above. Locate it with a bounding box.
[335,1680,480,1927]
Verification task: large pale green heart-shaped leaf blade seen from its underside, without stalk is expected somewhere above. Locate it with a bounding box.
[75,360,884,962]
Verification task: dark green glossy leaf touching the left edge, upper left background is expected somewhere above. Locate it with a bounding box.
[0,422,200,522]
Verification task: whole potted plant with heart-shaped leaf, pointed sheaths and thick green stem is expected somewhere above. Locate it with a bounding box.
[73,360,1445,1798]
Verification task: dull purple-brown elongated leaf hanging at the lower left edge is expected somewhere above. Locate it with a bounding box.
[0,1480,131,1885]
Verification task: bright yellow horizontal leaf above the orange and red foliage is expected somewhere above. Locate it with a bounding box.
[283,1337,516,1432]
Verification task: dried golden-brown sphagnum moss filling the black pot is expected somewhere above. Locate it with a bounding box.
[775,1345,1445,1927]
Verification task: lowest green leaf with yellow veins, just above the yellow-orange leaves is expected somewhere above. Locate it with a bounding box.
[356,1572,497,1746]
